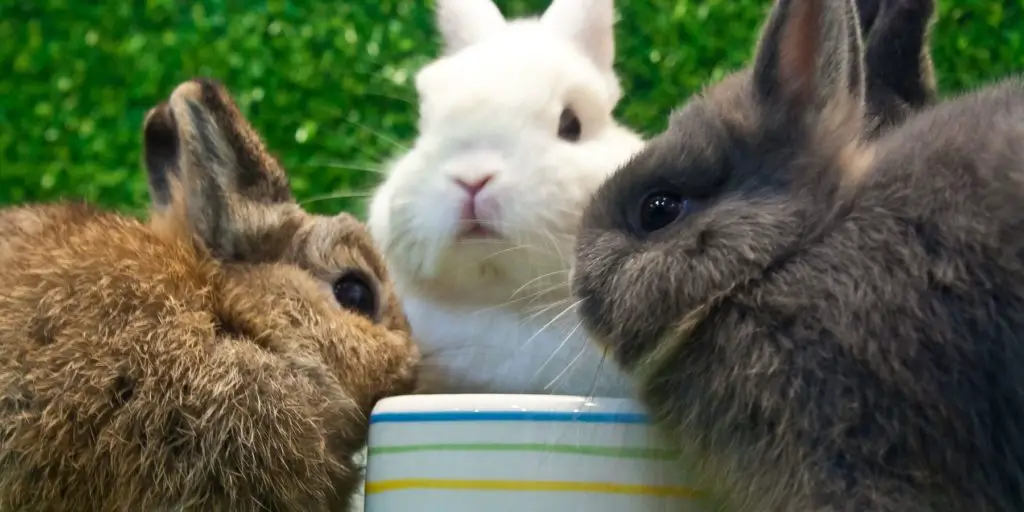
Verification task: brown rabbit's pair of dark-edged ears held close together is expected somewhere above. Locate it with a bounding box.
[143,79,294,260]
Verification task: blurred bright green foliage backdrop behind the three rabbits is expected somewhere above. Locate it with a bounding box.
[0,0,1024,217]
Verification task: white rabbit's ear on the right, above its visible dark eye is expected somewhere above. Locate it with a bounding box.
[544,0,615,71]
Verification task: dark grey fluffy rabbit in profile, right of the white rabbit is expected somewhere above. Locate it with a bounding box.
[573,0,1024,512]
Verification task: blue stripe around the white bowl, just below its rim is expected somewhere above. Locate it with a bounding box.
[370,411,648,425]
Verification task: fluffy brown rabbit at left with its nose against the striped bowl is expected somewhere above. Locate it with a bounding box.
[0,79,418,511]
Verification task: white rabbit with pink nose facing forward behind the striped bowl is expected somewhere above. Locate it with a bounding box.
[368,0,643,396]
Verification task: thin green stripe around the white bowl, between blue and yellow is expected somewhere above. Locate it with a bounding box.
[369,443,680,461]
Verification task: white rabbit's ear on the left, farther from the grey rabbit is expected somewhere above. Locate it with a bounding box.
[435,0,505,54]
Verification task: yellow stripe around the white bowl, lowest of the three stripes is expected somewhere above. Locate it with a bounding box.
[366,478,701,499]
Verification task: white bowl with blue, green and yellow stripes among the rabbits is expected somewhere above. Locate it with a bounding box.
[366,394,711,512]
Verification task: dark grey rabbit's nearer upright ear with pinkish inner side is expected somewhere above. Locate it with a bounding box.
[754,0,864,124]
